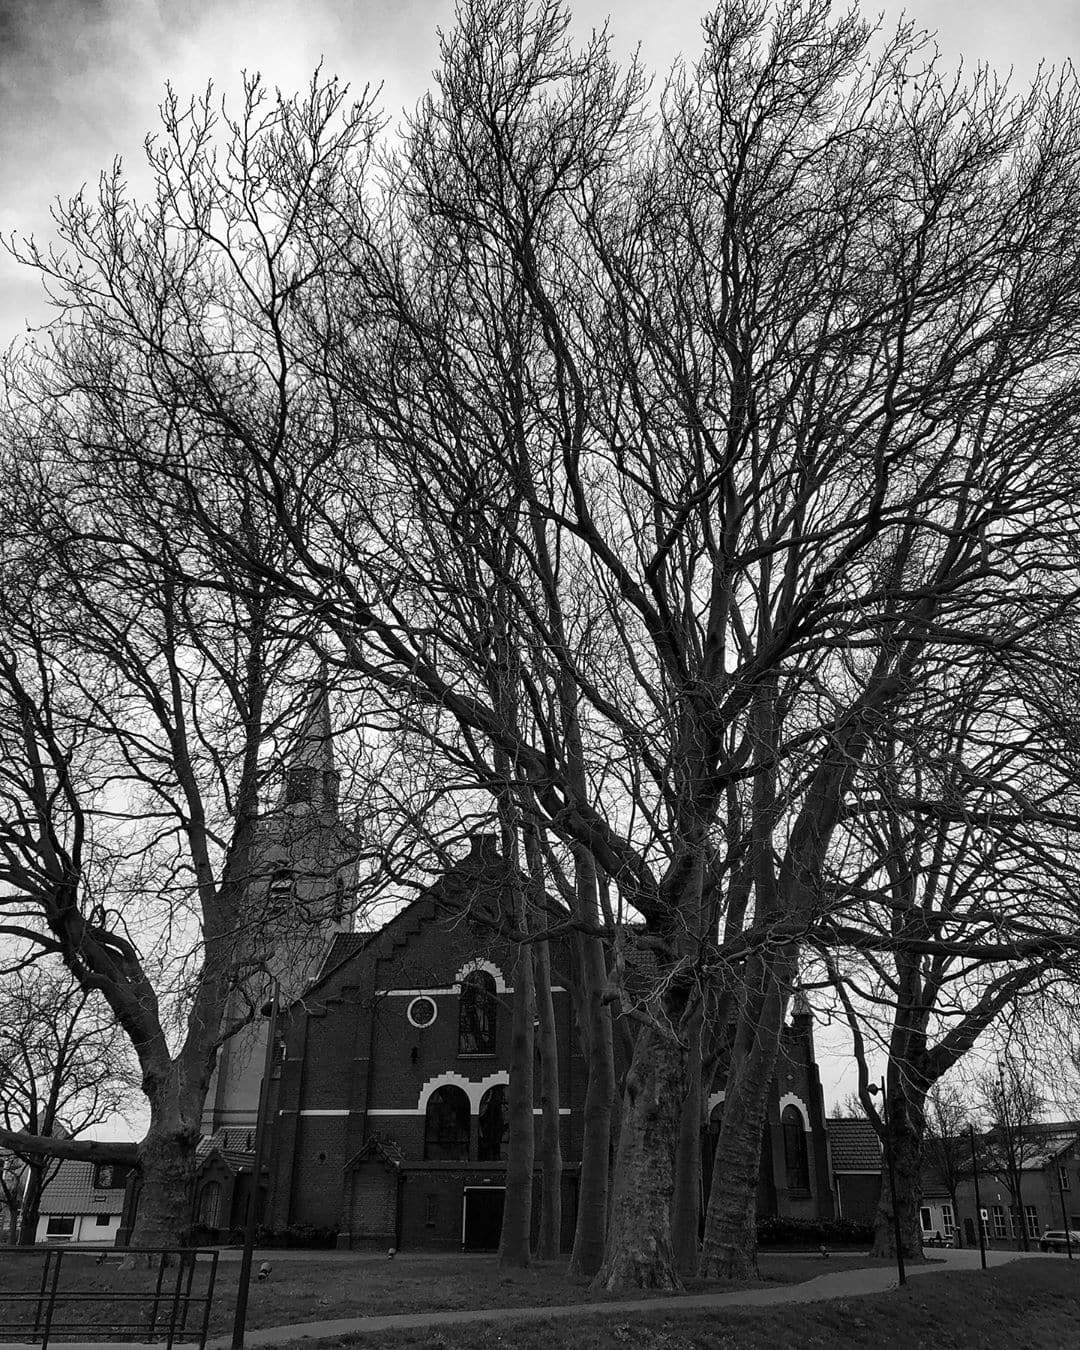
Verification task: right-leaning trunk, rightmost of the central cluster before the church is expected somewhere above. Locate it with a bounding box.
[701,959,787,1280]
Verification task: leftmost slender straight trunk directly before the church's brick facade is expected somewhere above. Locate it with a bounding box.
[498,944,536,1268]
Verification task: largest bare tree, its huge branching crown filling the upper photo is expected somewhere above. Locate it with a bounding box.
[10,0,1080,1288]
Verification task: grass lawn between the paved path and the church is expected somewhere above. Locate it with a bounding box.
[0,1249,888,1345]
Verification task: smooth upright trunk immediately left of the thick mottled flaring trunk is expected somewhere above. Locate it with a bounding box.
[568,937,616,1280]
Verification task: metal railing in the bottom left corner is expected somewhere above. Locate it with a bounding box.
[0,1245,217,1350]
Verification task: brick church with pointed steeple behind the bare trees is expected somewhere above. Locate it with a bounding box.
[194,699,834,1250]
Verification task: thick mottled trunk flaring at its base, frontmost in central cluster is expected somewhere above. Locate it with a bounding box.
[593,1019,686,1292]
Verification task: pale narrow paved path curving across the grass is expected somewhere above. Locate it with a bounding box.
[3,1247,1045,1350]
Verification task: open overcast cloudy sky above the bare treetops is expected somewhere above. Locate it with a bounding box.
[0,0,1080,1117]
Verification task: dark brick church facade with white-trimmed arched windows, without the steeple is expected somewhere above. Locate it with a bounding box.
[247,838,833,1250]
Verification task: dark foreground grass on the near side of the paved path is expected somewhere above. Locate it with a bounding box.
[272,1258,1080,1350]
